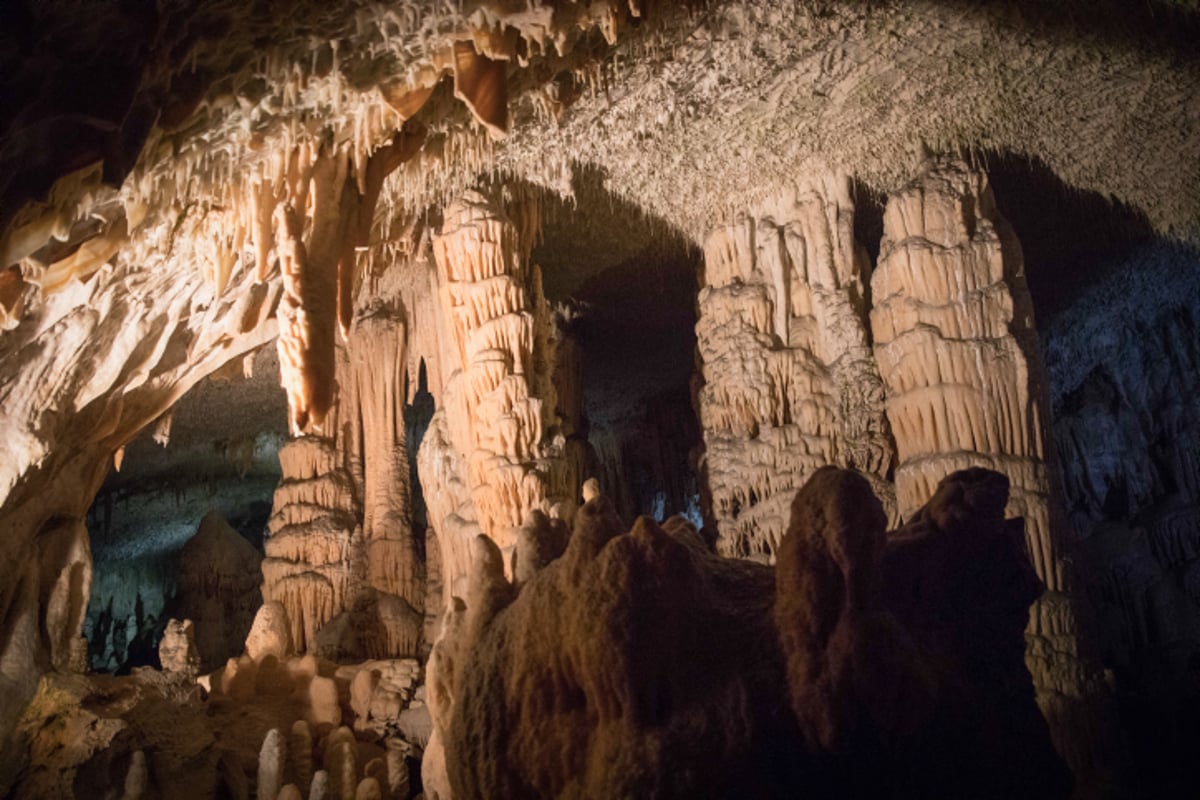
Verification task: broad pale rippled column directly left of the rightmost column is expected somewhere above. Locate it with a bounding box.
[696,175,893,557]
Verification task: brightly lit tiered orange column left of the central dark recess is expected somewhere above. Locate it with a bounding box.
[418,192,583,596]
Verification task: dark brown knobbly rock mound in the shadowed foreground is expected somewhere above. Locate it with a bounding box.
[434,468,1070,800]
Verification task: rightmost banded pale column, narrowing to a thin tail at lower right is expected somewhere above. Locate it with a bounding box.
[871,161,1105,776]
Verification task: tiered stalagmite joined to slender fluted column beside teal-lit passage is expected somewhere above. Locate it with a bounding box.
[263,311,425,658]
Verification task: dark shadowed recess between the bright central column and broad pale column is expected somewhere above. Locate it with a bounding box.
[533,176,703,528]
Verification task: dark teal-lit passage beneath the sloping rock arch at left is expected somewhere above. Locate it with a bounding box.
[84,345,287,673]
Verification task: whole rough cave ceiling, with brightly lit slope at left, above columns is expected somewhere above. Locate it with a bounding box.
[0,0,1200,513]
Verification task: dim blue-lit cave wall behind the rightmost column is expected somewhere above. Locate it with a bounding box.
[1043,242,1200,796]
